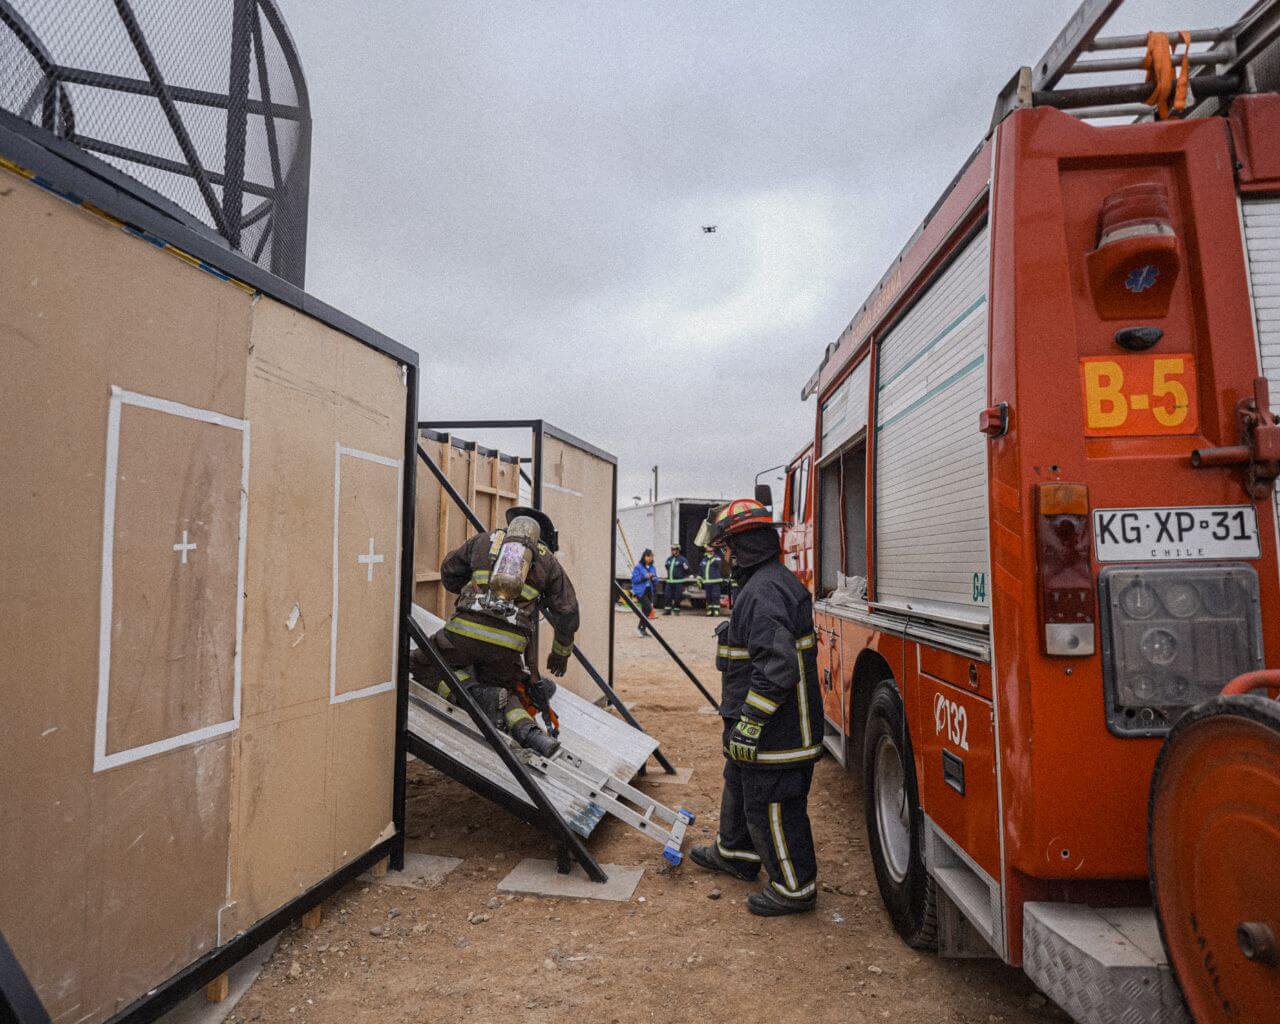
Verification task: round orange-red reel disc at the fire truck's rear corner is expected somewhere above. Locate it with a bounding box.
[1147,696,1280,1024]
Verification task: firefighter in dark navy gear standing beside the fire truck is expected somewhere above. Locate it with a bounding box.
[690,498,822,916]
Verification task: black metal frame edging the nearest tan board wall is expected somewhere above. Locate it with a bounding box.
[0,110,419,1024]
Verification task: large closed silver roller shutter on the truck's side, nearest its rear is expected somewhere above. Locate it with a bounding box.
[874,228,991,626]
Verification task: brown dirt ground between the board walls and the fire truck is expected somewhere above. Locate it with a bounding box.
[228,612,1066,1024]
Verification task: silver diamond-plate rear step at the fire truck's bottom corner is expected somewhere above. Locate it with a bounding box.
[1023,902,1192,1024]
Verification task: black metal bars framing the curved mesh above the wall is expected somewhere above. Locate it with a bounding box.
[0,0,311,287]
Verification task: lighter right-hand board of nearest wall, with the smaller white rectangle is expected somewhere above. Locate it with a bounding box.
[232,298,406,931]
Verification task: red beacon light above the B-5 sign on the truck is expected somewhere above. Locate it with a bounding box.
[1088,182,1179,320]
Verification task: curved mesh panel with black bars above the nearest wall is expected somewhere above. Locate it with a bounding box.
[0,0,311,285]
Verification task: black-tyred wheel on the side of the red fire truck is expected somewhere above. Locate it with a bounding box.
[863,680,937,950]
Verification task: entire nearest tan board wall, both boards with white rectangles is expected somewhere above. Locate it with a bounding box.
[0,163,407,1024]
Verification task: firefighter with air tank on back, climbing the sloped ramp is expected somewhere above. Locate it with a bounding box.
[415,506,579,755]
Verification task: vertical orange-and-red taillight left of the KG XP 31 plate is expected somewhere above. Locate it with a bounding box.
[1036,483,1096,658]
